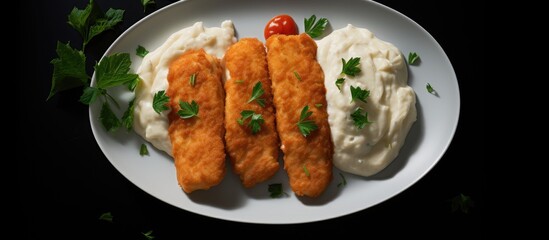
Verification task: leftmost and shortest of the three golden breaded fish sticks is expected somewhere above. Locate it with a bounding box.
[167,50,225,193]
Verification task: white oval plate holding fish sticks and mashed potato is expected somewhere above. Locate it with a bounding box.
[90,0,460,223]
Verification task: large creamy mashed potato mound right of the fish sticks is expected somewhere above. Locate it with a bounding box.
[317,24,416,176]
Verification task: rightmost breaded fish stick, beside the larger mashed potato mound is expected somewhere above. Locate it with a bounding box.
[266,34,335,197]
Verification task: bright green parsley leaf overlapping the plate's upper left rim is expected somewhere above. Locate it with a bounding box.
[95,53,139,89]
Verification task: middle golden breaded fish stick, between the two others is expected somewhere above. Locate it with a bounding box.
[225,38,280,188]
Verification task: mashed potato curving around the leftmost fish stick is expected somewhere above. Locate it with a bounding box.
[133,21,236,155]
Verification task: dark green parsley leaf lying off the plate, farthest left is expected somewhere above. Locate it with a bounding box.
[47,42,90,100]
